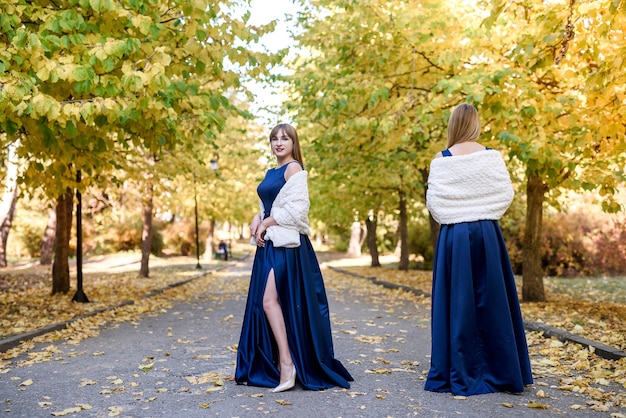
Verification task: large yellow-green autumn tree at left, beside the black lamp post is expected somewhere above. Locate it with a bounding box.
[0,0,272,292]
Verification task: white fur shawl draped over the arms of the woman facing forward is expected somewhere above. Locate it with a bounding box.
[252,170,310,248]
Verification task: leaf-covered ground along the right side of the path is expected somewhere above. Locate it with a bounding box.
[330,260,626,418]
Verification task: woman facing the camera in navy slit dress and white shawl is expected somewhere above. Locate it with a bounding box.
[235,123,352,392]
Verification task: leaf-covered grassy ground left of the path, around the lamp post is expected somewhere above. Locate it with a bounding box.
[0,253,227,338]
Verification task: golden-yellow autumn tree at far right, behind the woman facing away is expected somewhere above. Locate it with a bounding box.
[476,0,626,301]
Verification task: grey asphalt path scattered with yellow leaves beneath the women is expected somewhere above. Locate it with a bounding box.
[0,257,625,418]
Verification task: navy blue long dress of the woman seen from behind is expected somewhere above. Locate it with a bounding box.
[424,150,533,396]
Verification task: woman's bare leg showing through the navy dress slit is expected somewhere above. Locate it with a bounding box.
[263,269,294,383]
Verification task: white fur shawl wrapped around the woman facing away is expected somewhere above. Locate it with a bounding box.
[426,150,514,225]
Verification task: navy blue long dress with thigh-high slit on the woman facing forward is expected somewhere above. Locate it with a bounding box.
[235,164,353,390]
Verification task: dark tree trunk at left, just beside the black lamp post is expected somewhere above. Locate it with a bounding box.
[52,189,74,295]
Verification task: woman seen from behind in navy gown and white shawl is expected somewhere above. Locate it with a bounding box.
[424,104,533,395]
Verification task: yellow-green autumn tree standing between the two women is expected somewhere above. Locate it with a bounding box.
[290,0,476,269]
